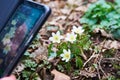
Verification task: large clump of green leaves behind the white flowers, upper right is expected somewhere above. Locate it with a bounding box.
[80,0,120,40]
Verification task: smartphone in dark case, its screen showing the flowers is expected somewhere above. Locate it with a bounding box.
[0,0,51,77]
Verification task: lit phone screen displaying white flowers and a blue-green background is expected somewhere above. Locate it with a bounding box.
[0,4,44,76]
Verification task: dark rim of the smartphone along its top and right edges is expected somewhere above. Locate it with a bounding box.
[1,0,51,77]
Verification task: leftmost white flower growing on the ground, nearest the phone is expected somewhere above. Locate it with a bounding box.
[49,31,63,43]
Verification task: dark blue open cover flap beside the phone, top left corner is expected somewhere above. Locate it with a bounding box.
[0,0,24,31]
